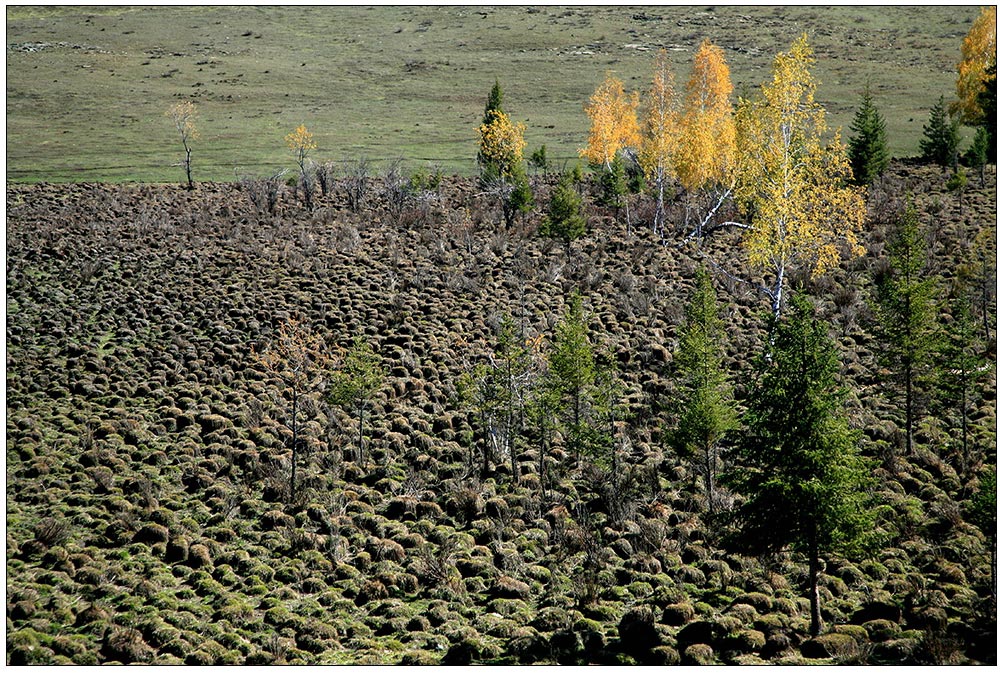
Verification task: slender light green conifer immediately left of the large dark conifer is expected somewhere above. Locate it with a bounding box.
[672,269,736,513]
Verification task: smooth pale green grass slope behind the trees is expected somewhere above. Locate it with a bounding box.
[7,6,979,181]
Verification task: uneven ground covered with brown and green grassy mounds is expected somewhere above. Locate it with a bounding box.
[6,165,996,664]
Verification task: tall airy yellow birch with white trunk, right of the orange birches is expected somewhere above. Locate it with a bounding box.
[734,35,865,317]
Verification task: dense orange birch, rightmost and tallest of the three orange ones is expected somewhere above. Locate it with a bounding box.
[676,39,736,238]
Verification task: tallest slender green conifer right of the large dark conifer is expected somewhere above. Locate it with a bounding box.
[874,203,938,454]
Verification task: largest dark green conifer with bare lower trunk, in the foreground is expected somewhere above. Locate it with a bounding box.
[727,296,872,636]
